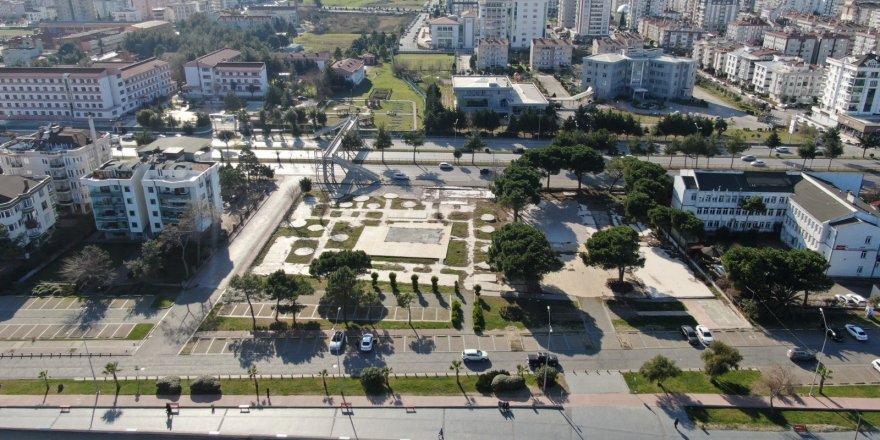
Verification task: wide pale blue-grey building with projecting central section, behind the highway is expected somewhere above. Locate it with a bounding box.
[581,49,697,100]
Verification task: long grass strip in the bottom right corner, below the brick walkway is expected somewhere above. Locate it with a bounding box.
[687,407,880,431]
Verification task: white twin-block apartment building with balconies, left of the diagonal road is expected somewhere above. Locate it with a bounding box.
[81,137,223,240]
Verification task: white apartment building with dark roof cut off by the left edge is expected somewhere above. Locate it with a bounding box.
[0,174,58,249]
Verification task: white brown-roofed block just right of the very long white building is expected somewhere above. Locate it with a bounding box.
[183,48,269,99]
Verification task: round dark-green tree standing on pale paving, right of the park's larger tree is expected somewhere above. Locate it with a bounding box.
[581,225,645,283]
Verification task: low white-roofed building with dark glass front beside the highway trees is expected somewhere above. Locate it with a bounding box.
[452,76,549,115]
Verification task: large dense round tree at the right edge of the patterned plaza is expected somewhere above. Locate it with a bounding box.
[489,223,562,289]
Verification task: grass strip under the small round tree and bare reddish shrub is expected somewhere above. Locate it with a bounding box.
[623,370,761,395]
